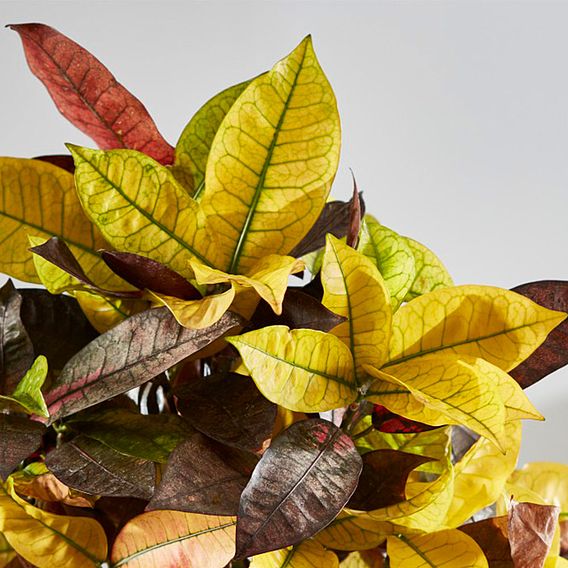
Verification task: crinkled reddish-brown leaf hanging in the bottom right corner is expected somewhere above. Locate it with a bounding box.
[508,502,560,568]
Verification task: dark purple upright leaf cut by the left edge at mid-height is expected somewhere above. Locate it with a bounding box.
[0,280,34,394]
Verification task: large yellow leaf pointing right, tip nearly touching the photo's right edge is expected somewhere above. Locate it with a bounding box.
[384,285,566,371]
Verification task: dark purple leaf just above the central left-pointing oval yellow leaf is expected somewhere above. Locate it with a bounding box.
[251,288,346,332]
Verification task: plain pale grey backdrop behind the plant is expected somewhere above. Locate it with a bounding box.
[0,0,568,463]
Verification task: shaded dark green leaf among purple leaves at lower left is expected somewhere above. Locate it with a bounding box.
[68,408,192,463]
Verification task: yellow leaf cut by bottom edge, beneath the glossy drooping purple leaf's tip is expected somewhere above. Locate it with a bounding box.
[250,540,339,568]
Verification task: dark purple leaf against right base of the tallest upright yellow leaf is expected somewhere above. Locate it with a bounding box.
[290,195,365,258]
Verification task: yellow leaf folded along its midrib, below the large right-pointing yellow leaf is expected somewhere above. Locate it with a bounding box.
[365,353,506,447]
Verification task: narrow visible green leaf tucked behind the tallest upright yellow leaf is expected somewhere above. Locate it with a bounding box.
[175,76,251,200]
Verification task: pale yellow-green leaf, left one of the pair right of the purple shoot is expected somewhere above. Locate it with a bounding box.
[357,215,416,312]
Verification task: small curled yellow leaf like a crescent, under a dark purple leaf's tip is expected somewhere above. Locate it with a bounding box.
[149,286,235,329]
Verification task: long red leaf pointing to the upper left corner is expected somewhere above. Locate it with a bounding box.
[9,24,174,164]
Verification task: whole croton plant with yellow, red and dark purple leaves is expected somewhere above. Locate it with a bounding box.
[0,24,568,568]
